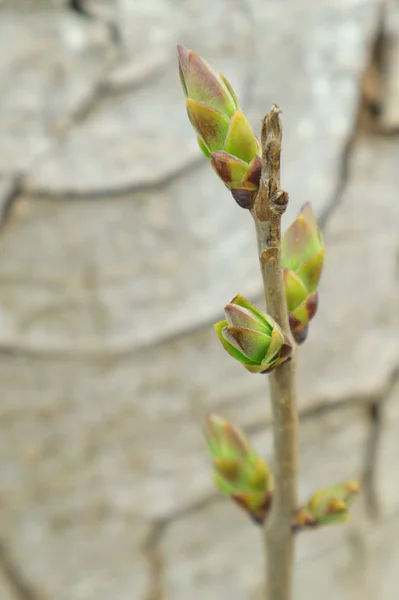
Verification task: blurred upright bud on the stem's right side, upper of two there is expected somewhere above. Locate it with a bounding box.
[281,202,324,344]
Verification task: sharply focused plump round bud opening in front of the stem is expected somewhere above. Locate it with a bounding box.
[214,295,292,373]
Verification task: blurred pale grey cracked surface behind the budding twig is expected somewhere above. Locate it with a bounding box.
[0,0,399,600]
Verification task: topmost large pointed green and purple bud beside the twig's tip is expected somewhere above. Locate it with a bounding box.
[177,46,262,208]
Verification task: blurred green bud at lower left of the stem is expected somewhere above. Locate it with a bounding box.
[204,415,273,523]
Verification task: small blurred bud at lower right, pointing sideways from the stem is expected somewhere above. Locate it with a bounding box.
[293,481,360,531]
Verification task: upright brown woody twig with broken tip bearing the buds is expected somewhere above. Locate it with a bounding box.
[251,105,298,600]
